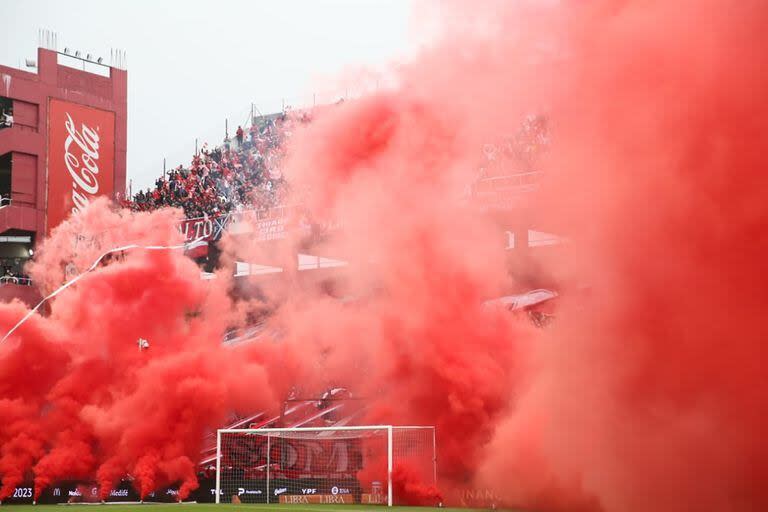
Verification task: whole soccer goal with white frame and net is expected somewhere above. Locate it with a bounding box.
[216,425,437,506]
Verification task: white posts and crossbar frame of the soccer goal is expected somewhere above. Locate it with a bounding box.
[215,425,437,507]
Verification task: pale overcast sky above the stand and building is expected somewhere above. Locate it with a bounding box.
[0,0,418,192]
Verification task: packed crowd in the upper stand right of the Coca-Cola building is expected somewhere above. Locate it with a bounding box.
[122,113,309,218]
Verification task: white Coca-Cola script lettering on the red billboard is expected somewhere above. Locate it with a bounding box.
[64,112,99,213]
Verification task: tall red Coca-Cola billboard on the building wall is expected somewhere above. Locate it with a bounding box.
[46,98,115,233]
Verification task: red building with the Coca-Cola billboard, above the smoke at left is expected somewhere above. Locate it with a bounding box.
[0,48,128,275]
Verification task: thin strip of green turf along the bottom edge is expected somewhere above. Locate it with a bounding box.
[2,503,492,512]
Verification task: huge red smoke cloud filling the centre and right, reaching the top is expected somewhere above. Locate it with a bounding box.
[260,2,768,510]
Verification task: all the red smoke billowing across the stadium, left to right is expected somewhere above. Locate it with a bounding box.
[0,0,768,512]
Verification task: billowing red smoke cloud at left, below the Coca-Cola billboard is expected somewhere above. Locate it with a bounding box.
[0,204,284,498]
